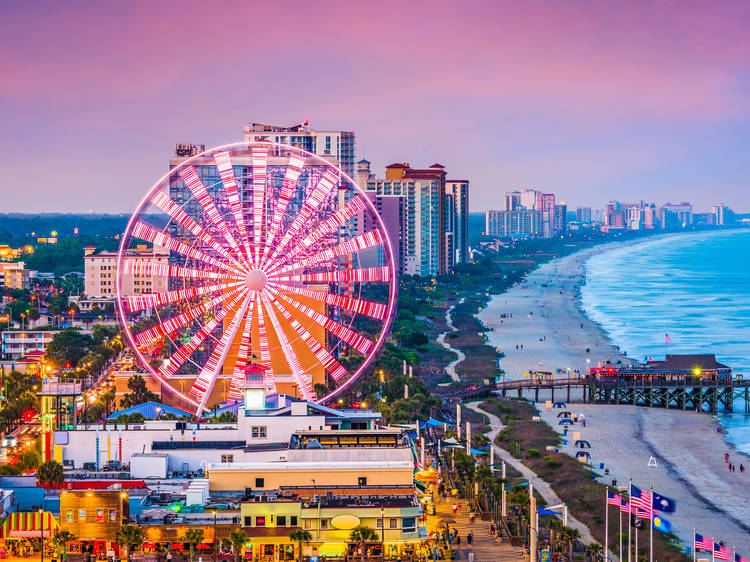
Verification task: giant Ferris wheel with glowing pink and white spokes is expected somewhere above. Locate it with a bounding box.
[115,142,397,415]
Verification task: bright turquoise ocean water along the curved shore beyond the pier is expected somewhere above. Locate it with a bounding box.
[581,230,750,453]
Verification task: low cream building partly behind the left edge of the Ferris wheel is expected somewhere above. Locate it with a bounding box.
[83,245,169,299]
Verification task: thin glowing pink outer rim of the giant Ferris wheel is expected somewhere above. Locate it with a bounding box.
[115,141,398,415]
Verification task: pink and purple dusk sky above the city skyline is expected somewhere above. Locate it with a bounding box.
[0,0,750,212]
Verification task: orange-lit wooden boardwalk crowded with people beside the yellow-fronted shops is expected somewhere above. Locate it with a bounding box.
[427,490,526,562]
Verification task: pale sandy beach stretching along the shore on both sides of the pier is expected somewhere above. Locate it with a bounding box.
[479,240,750,558]
